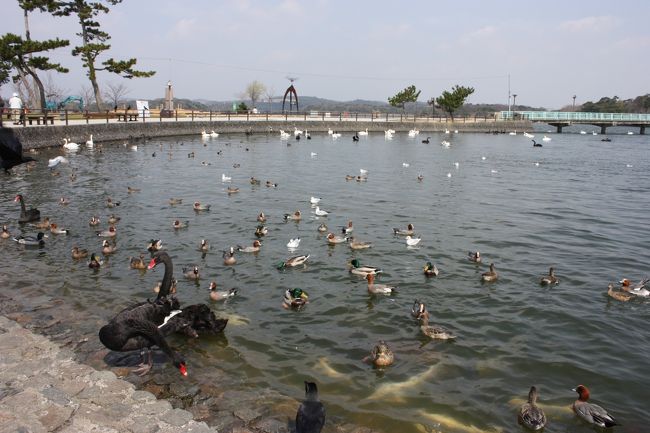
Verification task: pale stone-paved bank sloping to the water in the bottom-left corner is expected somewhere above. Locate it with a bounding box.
[0,316,217,433]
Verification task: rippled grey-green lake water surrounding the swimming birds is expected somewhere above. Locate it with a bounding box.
[0,132,650,433]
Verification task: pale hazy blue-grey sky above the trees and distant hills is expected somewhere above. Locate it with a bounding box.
[0,0,650,109]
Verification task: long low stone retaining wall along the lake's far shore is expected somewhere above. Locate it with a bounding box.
[6,119,533,150]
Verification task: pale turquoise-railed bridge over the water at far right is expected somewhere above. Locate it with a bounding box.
[499,111,650,134]
